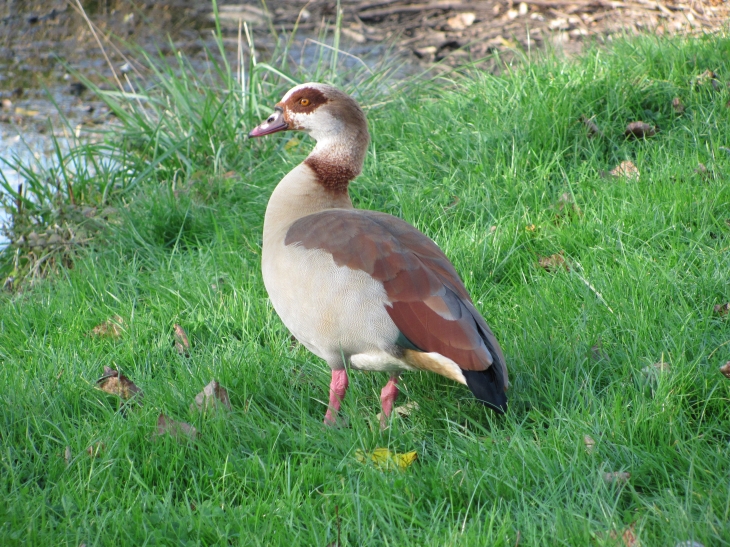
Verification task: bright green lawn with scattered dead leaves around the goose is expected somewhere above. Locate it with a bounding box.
[0,33,730,547]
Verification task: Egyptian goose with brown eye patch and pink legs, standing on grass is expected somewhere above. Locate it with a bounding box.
[249,83,508,427]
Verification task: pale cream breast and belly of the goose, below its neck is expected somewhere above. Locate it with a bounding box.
[261,164,414,370]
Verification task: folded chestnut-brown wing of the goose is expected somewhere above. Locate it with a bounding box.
[285,209,507,387]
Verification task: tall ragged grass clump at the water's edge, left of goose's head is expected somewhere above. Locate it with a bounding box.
[0,4,395,288]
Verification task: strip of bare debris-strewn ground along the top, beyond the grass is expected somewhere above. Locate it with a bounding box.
[0,0,730,88]
